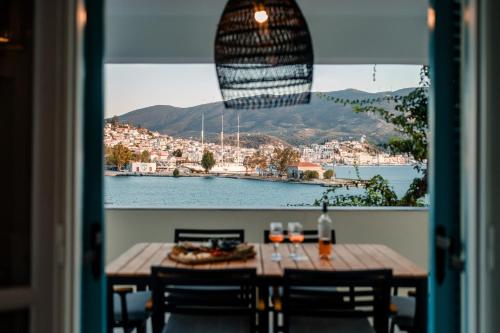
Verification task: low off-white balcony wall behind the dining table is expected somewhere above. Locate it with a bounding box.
[106,208,428,269]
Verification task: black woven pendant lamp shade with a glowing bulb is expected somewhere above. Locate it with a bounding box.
[215,0,313,109]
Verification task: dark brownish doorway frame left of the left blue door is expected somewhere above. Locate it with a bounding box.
[0,0,85,333]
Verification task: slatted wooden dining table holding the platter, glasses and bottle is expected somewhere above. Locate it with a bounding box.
[106,243,428,332]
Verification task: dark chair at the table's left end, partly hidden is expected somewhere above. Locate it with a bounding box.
[109,287,151,333]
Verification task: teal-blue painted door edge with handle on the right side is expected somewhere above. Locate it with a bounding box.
[428,0,461,333]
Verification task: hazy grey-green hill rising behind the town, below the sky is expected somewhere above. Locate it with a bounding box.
[113,88,413,145]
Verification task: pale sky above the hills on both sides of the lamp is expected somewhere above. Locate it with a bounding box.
[105,64,421,118]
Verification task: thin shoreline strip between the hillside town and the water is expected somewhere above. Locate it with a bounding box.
[104,171,364,187]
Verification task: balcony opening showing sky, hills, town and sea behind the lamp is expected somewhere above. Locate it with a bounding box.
[104,64,426,208]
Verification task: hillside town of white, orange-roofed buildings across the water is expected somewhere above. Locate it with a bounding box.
[104,121,413,178]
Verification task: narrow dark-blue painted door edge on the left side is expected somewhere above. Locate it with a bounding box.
[81,0,106,333]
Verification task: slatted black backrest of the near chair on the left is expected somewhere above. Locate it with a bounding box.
[151,266,256,332]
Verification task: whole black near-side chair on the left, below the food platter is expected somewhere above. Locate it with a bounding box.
[151,267,256,333]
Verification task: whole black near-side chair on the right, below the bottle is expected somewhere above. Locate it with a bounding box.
[283,269,392,333]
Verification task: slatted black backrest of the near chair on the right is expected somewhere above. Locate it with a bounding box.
[283,269,392,333]
